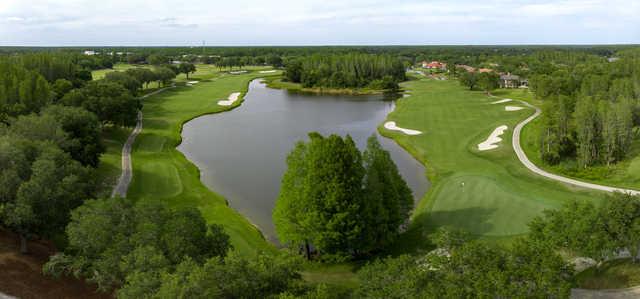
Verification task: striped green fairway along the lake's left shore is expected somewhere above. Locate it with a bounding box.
[102,68,274,254]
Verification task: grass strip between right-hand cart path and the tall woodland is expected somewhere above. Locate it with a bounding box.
[494,89,640,190]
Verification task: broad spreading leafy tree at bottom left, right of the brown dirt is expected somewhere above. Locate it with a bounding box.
[44,198,230,296]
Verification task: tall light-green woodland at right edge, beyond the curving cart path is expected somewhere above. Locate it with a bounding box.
[530,50,640,167]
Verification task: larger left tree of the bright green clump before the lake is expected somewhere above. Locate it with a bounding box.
[274,133,364,259]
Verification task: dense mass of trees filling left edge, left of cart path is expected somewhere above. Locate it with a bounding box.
[0,53,154,252]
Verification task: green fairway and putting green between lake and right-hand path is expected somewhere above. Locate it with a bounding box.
[380,79,601,251]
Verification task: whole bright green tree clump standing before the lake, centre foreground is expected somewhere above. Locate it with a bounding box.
[273,133,413,260]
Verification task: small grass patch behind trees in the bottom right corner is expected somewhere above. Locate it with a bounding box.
[575,259,640,289]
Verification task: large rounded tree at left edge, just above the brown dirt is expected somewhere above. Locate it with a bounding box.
[0,135,94,253]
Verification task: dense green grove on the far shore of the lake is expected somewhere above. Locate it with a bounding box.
[284,53,406,89]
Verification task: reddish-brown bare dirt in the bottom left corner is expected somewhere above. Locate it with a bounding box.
[0,228,113,299]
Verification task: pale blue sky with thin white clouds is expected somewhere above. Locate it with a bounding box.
[0,0,640,46]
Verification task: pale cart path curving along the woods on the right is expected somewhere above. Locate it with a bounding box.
[512,101,640,195]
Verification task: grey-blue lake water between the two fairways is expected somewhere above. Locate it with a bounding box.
[178,80,429,241]
